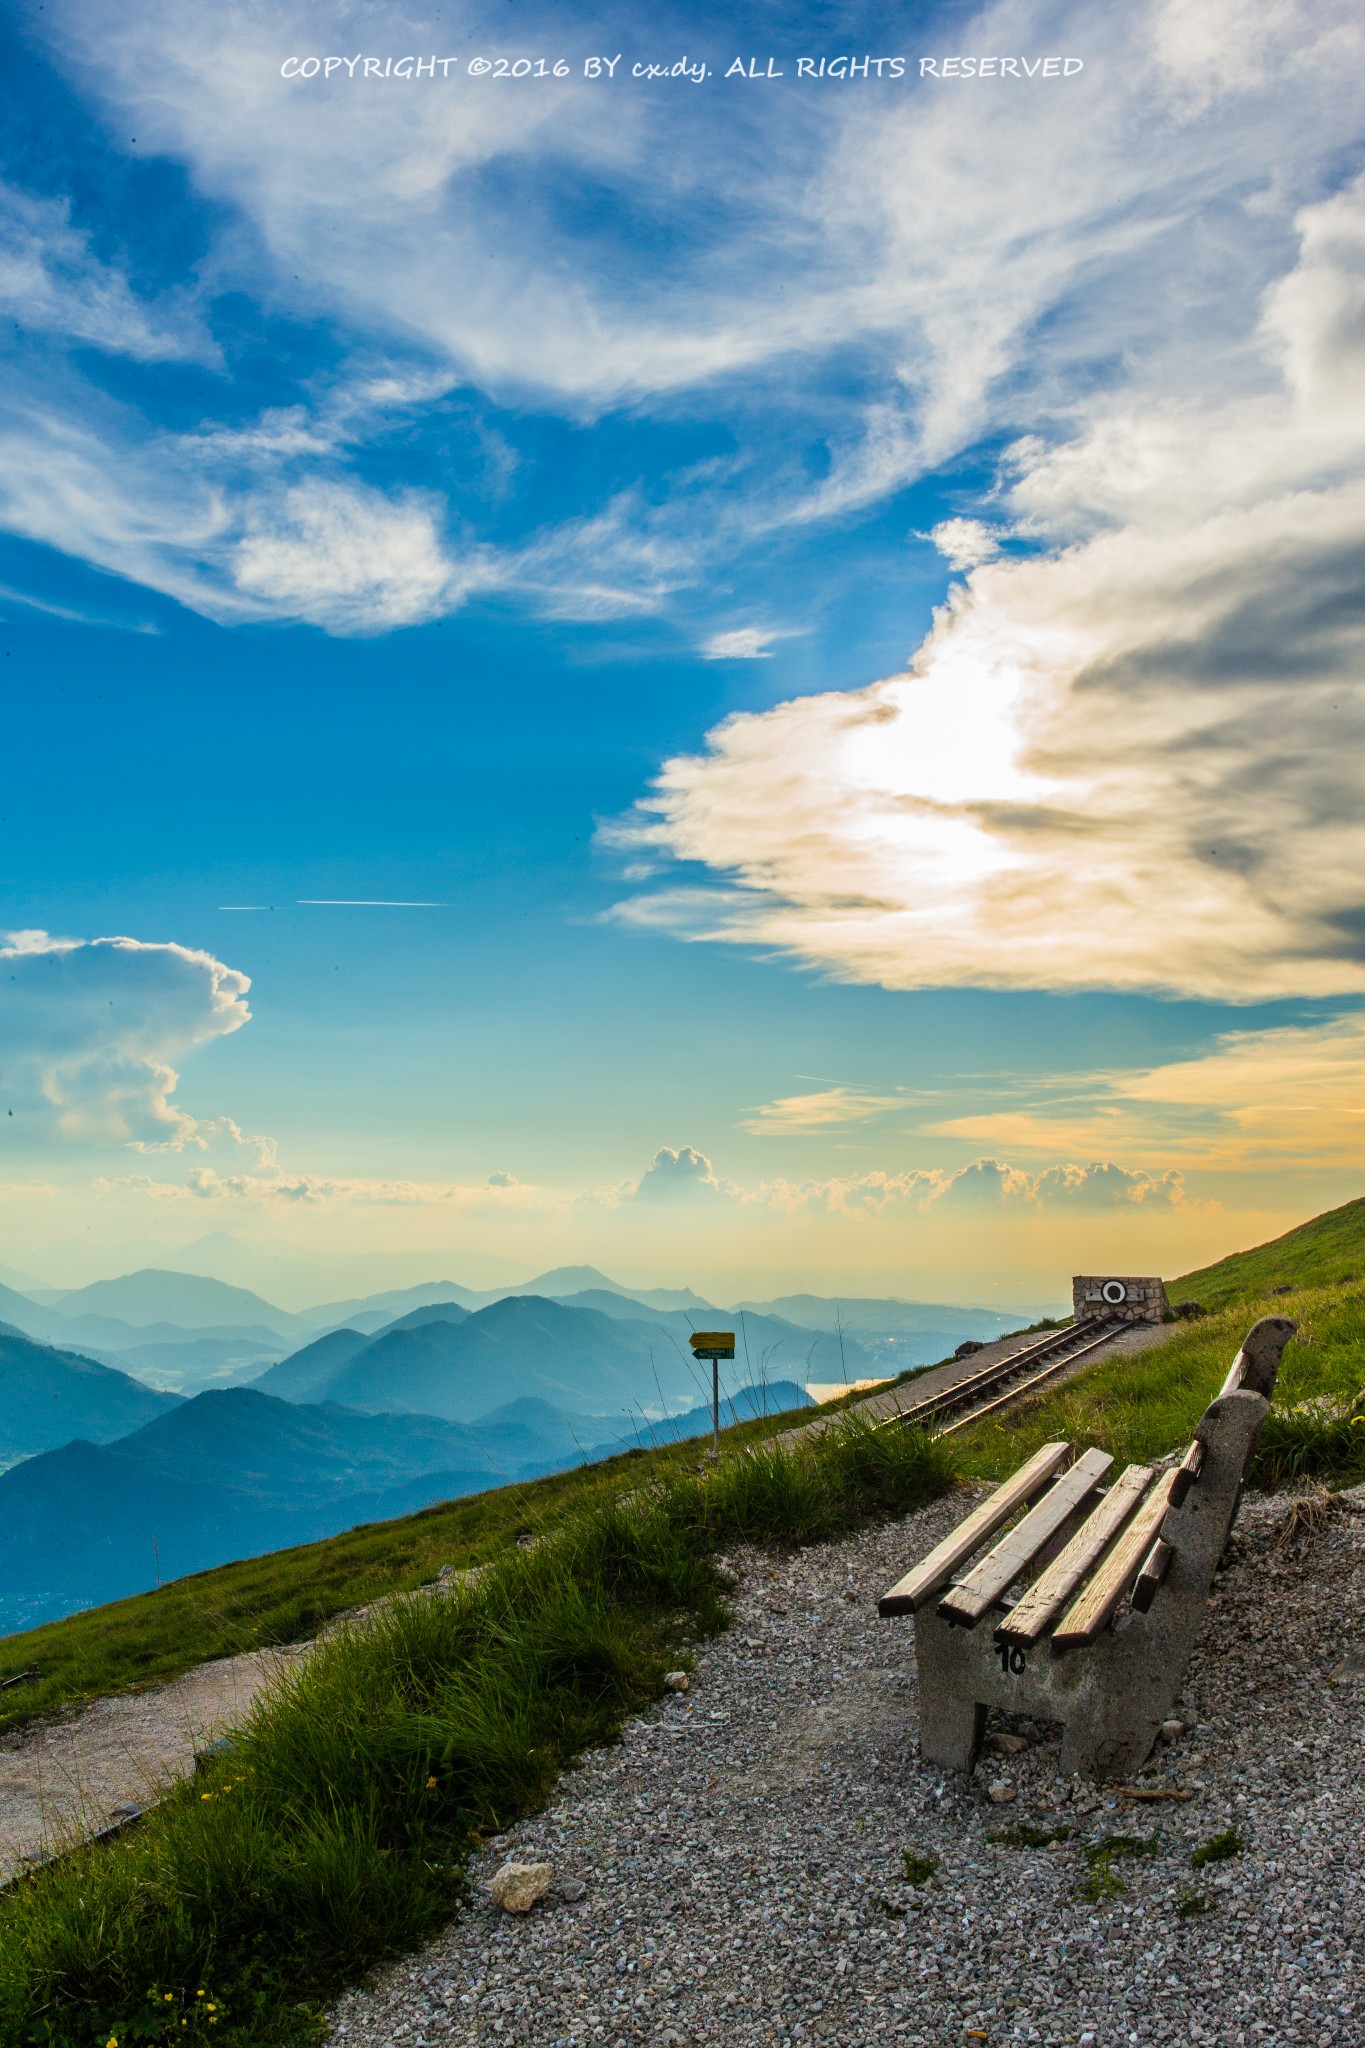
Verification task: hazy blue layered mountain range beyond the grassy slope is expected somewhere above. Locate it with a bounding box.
[0,1266,1031,1628]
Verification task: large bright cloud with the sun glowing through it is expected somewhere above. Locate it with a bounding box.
[616,180,1365,999]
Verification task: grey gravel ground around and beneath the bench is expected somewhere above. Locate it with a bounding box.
[329,1495,1365,2048]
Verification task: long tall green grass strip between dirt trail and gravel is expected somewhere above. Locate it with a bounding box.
[0,1421,954,2048]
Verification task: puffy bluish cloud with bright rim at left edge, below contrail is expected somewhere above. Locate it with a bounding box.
[0,932,259,1157]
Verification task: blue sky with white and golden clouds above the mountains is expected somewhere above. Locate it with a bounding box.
[0,0,1365,1300]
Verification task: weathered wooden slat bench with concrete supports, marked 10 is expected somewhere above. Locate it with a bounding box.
[878,1315,1295,1780]
